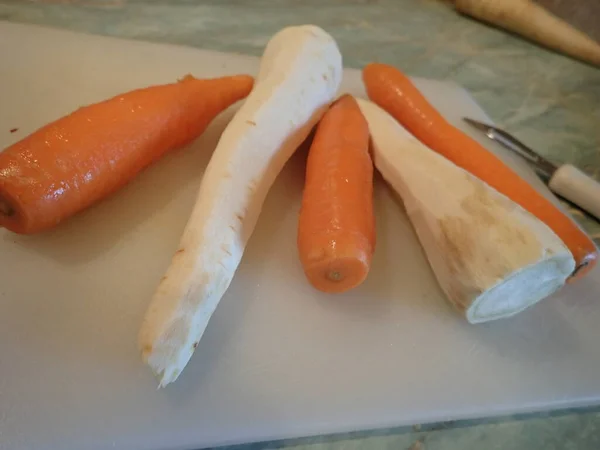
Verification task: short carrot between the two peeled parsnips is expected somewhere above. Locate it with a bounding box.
[298,95,375,293]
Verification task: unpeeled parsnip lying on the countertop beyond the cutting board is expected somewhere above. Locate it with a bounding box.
[454,0,600,66]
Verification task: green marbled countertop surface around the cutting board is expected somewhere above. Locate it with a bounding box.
[0,0,600,450]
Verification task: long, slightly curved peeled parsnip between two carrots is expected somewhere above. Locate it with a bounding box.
[139,25,342,387]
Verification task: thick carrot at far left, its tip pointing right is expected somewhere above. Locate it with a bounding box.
[0,75,253,234]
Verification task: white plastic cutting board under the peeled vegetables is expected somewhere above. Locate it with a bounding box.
[0,22,600,450]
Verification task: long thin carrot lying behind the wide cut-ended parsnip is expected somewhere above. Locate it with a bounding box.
[363,64,598,281]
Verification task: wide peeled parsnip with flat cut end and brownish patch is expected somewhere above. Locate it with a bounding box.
[359,100,575,323]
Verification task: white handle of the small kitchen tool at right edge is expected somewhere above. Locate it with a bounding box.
[548,164,600,219]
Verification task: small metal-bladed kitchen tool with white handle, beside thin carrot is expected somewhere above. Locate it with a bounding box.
[463,117,600,220]
